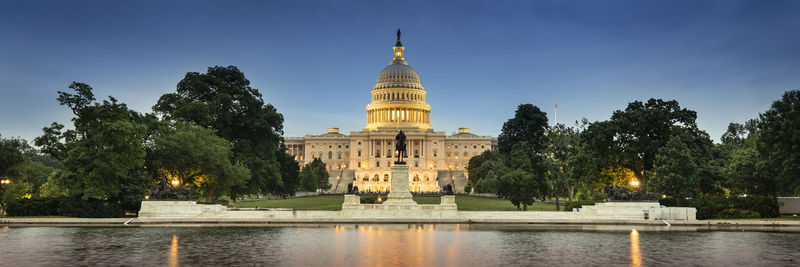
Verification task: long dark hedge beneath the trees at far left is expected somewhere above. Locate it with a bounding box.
[6,197,125,218]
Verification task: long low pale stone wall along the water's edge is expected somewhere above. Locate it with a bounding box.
[139,199,697,223]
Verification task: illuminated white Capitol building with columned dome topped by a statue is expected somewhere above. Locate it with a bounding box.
[285,30,497,193]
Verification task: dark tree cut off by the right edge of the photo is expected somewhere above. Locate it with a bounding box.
[757,90,800,198]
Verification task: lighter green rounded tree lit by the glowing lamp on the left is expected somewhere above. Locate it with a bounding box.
[151,123,250,203]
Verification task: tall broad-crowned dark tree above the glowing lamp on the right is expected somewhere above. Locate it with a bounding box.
[582,98,699,194]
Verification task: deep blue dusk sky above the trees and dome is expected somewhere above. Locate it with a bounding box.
[0,0,800,140]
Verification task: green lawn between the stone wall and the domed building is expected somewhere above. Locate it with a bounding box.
[234,195,555,211]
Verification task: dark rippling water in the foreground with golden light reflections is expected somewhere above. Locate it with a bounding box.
[0,224,800,266]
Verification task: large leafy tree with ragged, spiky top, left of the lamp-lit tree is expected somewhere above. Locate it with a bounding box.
[35,82,150,211]
